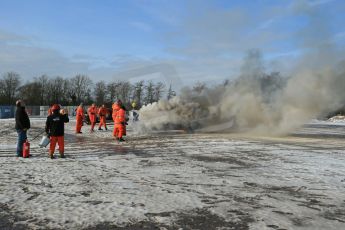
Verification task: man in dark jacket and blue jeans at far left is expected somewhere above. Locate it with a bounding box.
[15,100,30,157]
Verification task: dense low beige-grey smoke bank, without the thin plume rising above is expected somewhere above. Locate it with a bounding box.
[140,49,345,134]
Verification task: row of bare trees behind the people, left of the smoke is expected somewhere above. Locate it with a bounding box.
[0,72,176,109]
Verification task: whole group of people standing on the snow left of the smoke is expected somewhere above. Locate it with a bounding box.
[15,100,127,159]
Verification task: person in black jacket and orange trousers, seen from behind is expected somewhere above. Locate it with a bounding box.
[46,104,69,159]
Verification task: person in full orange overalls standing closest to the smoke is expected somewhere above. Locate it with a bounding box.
[112,100,126,142]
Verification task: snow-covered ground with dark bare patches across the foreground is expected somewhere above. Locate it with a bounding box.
[0,118,345,229]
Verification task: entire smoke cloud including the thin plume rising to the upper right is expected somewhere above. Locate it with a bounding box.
[140,0,345,135]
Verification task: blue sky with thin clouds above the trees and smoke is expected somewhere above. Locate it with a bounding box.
[0,0,345,85]
